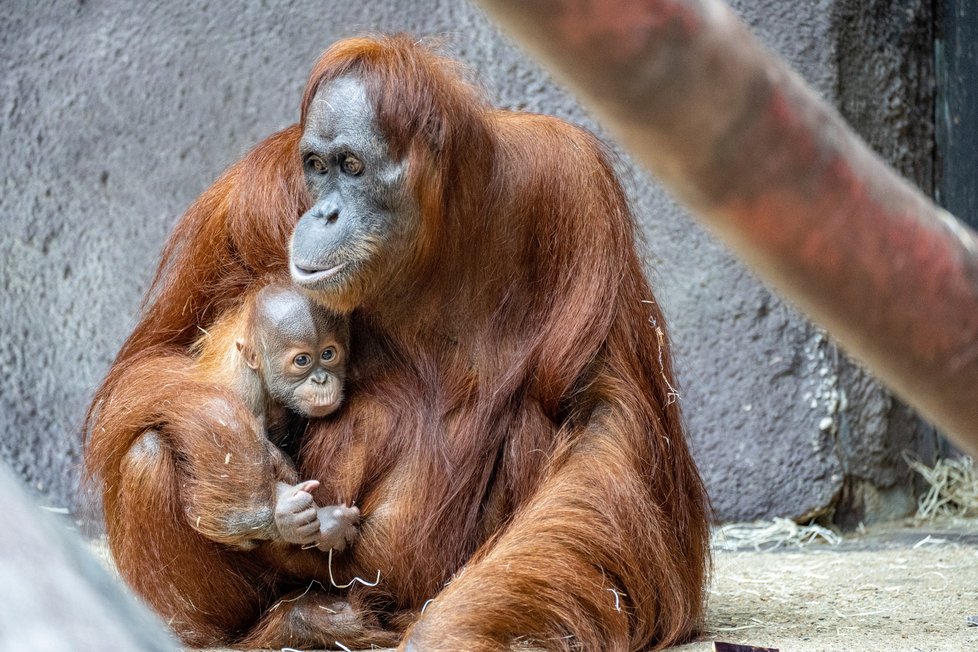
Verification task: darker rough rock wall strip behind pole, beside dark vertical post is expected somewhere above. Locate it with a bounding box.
[833,0,939,525]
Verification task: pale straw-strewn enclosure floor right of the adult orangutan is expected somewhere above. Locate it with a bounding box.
[97,520,978,652]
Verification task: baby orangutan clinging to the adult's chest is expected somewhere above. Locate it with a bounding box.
[194,282,360,551]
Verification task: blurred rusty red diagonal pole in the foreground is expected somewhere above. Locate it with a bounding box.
[480,0,978,453]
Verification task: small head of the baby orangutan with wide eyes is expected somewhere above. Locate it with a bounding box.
[249,288,349,417]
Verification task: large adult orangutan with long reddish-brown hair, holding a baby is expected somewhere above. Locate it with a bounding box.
[87,36,708,651]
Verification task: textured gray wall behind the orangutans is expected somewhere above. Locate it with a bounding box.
[0,0,930,519]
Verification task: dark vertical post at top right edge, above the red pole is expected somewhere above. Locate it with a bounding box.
[935,0,978,227]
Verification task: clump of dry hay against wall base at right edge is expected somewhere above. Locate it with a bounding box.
[907,457,978,520]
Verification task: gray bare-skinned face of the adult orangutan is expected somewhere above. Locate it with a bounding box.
[289,77,418,311]
